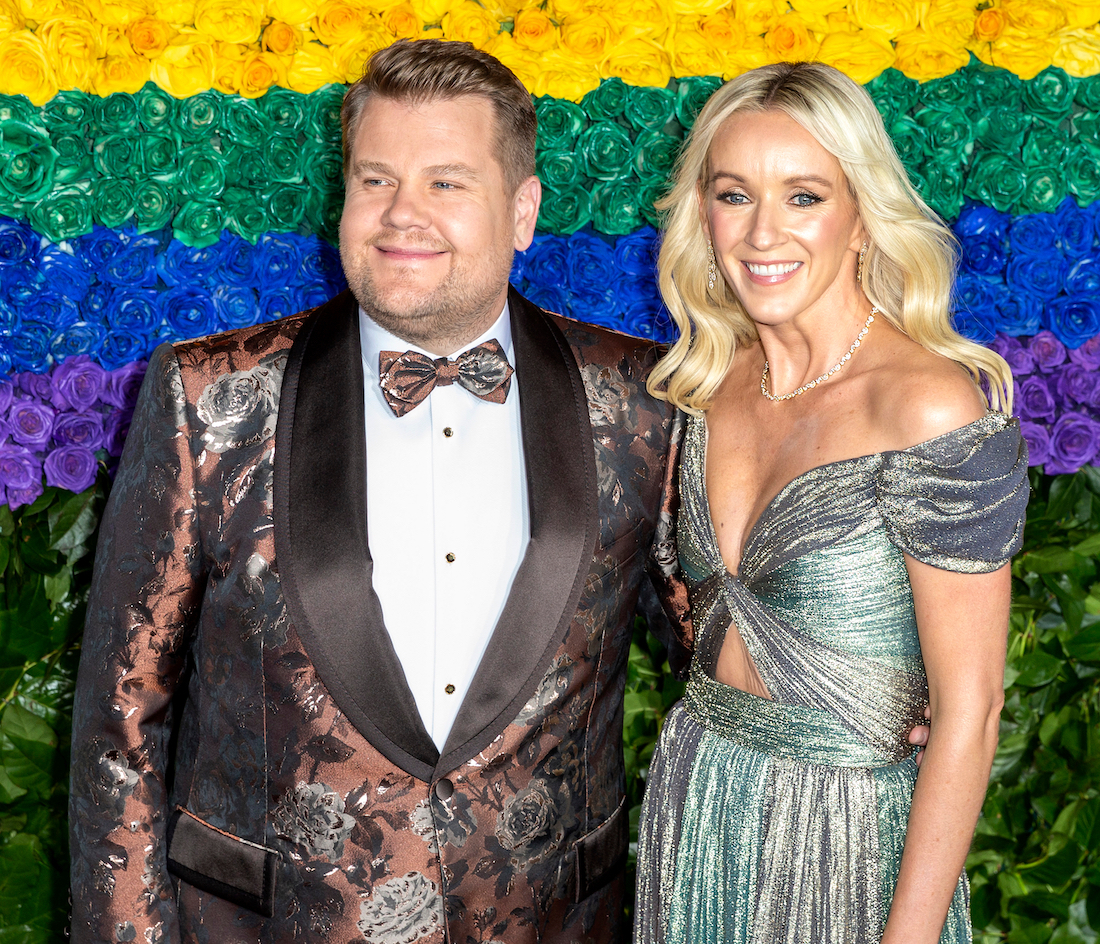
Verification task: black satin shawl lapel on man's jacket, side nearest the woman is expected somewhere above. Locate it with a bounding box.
[437,290,598,773]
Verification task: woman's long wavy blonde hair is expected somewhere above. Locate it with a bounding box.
[648,63,1012,414]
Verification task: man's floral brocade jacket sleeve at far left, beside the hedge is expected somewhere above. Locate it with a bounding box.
[69,344,206,944]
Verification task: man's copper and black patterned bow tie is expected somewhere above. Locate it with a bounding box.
[378,338,513,416]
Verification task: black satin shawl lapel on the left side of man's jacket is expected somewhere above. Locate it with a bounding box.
[274,292,439,780]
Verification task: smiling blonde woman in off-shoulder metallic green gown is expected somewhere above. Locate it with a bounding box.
[636,63,1027,944]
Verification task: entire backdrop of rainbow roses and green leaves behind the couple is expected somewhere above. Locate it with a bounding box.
[0,0,1100,944]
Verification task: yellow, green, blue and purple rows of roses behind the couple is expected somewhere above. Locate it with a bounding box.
[0,0,1100,941]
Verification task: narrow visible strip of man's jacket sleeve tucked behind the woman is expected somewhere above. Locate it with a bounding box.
[646,409,692,678]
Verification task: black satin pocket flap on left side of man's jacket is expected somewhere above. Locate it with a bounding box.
[168,806,277,918]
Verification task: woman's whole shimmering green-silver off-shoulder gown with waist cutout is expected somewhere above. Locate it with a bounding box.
[635,413,1029,944]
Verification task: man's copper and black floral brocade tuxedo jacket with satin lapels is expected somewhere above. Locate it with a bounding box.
[70,293,690,944]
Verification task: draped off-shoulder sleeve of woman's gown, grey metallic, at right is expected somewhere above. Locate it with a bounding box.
[876,411,1030,573]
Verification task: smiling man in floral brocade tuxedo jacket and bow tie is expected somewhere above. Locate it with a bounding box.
[70,41,686,944]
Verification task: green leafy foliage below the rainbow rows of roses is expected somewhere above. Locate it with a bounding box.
[0,468,1100,944]
